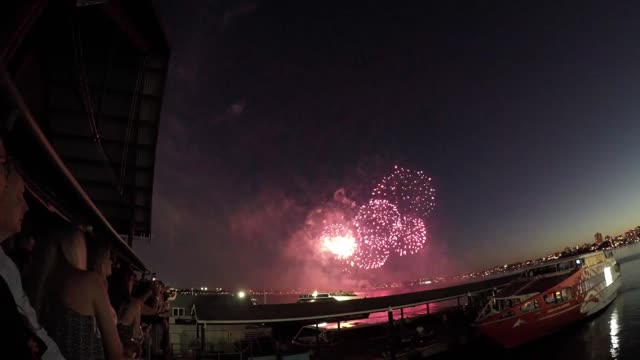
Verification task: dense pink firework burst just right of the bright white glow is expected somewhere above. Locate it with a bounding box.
[350,199,402,270]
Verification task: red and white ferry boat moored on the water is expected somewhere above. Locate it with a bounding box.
[475,250,622,348]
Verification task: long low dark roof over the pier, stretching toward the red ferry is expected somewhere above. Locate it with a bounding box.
[194,275,514,324]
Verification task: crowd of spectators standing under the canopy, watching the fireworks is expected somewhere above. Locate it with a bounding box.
[0,136,169,360]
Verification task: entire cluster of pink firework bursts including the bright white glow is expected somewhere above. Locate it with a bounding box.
[316,166,435,271]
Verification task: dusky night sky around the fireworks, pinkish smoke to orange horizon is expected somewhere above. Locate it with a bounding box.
[136,0,640,288]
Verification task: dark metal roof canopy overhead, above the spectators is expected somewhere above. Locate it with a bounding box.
[0,0,169,269]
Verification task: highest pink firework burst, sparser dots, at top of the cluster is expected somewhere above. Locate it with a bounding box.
[371,166,436,219]
